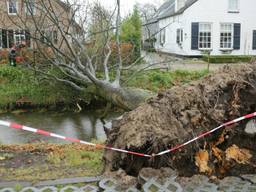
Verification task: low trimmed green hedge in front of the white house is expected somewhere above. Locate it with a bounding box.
[203,55,253,63]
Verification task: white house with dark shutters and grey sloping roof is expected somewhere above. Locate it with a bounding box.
[144,0,256,56]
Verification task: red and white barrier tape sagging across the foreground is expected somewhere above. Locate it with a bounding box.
[0,112,256,158]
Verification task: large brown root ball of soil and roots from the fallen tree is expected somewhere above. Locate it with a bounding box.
[104,64,256,176]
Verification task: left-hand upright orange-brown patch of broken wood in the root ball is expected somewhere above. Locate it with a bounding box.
[195,150,212,174]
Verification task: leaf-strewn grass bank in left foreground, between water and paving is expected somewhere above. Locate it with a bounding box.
[0,144,103,182]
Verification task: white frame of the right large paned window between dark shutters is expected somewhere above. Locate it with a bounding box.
[220,23,234,50]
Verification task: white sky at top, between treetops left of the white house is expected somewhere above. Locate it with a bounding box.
[90,0,164,16]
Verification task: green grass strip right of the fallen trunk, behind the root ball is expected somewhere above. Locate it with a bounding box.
[127,70,208,92]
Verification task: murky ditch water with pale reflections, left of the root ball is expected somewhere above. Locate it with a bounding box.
[0,111,120,144]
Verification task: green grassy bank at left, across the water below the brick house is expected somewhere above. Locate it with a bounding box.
[0,65,83,109]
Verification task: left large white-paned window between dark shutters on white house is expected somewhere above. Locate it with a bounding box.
[198,23,212,49]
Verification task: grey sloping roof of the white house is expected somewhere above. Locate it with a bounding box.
[147,0,198,24]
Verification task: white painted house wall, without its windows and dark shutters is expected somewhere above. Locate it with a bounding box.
[156,0,256,56]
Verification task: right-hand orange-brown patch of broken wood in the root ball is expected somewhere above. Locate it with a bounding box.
[225,145,252,164]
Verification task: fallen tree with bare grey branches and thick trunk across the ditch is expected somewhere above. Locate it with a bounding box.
[0,0,152,110]
